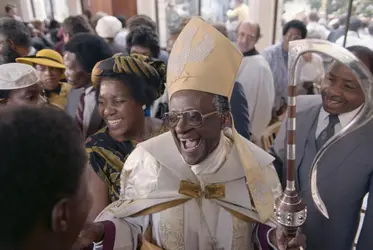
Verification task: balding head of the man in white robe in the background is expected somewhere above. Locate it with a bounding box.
[237,20,261,53]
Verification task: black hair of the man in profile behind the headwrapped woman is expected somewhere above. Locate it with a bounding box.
[65,33,112,73]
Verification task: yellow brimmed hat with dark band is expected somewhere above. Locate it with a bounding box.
[16,49,66,69]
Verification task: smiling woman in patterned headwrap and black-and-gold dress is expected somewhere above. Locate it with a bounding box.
[86,54,167,220]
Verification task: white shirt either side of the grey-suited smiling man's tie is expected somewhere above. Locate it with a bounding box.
[315,106,362,138]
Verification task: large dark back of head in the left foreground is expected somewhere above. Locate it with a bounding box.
[0,107,91,249]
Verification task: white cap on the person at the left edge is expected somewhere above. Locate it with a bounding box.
[0,63,40,90]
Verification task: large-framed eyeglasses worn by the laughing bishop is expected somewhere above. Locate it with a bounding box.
[162,110,217,128]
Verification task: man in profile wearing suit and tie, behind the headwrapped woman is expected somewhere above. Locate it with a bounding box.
[64,33,112,137]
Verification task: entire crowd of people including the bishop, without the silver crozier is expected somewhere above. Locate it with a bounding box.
[0,1,373,250]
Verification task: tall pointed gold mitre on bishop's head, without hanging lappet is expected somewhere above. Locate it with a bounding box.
[167,17,242,99]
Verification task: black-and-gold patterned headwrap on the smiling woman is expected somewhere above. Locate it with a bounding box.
[92,53,166,97]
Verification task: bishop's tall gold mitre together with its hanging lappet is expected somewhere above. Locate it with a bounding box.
[166,17,274,222]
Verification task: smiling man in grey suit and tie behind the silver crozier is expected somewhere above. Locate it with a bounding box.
[274,46,373,250]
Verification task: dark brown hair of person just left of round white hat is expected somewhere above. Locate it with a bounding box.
[62,15,94,39]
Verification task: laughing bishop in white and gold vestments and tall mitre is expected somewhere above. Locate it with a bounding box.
[87,18,306,250]
